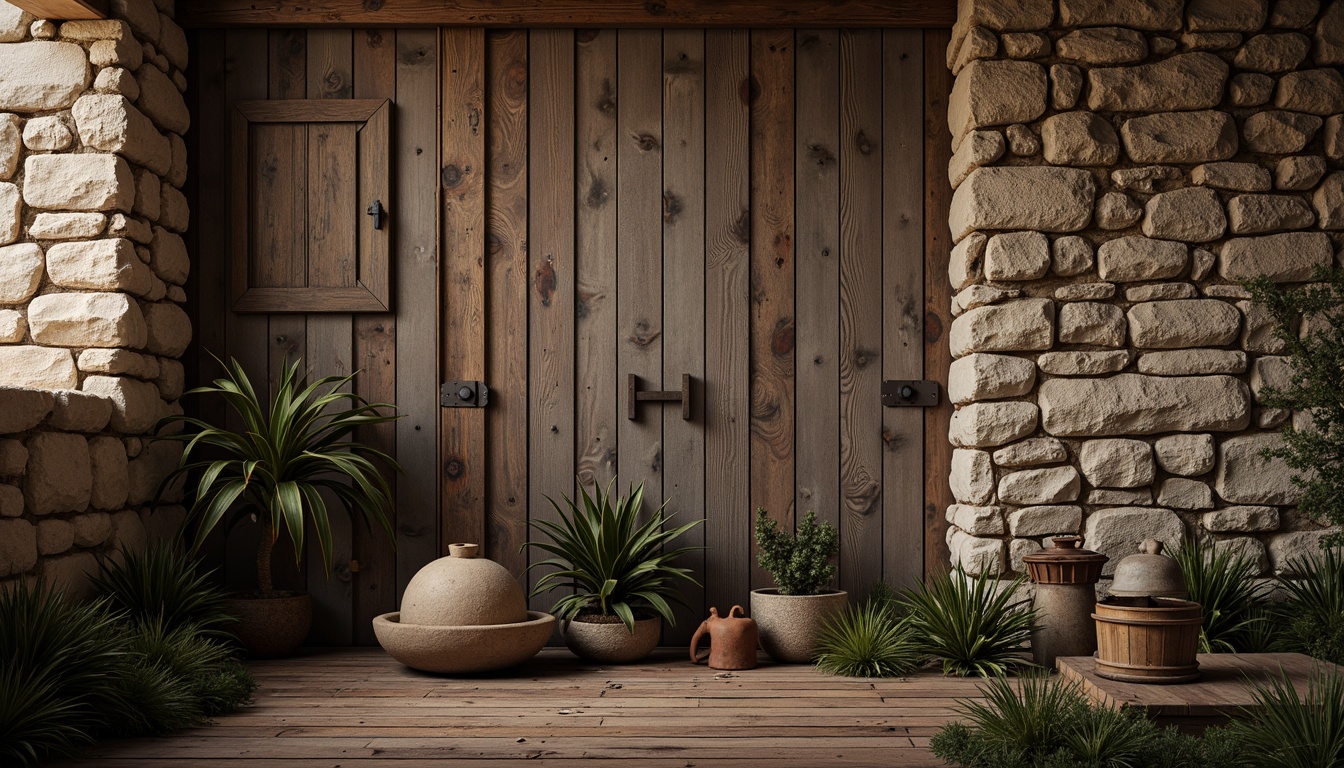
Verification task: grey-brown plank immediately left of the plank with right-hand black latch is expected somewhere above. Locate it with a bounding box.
[840,30,884,597]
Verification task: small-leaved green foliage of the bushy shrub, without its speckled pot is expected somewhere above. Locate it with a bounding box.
[755,508,840,594]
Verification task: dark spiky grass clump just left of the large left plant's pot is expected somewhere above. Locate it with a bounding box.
[93,543,233,631]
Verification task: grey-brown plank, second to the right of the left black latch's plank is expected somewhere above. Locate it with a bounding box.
[527,30,575,609]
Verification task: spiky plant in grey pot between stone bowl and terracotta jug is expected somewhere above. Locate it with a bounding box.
[523,479,704,663]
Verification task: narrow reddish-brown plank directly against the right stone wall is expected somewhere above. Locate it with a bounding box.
[919,30,953,583]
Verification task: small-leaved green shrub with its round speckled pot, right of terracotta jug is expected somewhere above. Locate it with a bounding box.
[751,508,849,664]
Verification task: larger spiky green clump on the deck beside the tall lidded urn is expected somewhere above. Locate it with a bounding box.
[900,565,1036,678]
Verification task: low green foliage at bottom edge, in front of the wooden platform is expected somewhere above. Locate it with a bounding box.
[930,673,1247,768]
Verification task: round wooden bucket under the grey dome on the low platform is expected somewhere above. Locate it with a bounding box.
[1093,597,1204,683]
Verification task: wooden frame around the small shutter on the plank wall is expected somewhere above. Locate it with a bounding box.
[230,98,392,312]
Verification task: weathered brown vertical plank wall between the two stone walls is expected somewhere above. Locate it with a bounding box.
[192,28,950,644]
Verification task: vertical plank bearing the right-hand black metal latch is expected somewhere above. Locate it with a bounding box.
[880,30,924,588]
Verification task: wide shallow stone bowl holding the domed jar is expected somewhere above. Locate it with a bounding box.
[374,611,555,674]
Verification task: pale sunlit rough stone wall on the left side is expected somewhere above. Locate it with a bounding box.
[0,0,191,593]
